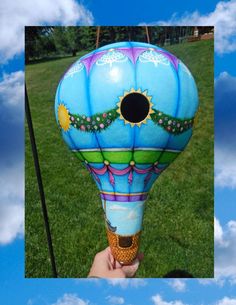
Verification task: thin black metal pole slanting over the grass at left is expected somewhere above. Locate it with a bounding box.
[25,84,57,278]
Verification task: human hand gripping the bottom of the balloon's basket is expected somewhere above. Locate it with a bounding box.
[88,247,143,278]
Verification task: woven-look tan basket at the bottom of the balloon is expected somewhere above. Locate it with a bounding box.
[107,229,141,265]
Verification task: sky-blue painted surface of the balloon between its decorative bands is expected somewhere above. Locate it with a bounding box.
[55,42,198,235]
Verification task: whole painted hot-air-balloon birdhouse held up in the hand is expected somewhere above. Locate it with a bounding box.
[55,42,198,264]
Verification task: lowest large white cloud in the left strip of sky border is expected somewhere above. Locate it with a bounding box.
[0,163,24,245]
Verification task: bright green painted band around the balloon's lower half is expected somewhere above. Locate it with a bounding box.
[75,150,179,164]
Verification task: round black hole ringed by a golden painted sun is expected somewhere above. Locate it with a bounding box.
[120,92,150,123]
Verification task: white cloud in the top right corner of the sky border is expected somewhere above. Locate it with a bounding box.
[140,0,236,54]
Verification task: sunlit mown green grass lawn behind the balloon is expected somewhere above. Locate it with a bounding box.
[25,41,214,278]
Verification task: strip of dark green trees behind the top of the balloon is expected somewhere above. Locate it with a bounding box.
[25,26,212,63]
